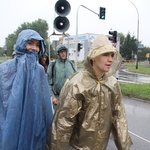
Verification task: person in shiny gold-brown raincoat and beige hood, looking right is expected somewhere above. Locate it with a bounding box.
[51,35,132,150]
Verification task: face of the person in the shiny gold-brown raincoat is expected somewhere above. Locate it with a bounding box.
[92,52,114,74]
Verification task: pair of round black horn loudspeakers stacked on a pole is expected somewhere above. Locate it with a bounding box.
[54,0,71,32]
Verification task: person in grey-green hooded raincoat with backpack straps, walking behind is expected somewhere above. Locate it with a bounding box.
[47,44,76,111]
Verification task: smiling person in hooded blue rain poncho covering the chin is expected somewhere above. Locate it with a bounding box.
[0,29,53,150]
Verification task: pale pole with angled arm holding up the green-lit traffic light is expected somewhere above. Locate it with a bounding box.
[75,5,99,70]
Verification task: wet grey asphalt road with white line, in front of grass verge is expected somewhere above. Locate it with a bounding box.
[107,97,150,150]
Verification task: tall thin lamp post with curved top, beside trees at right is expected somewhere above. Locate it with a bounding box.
[129,0,139,69]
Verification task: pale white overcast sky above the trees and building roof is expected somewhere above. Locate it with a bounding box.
[0,0,150,47]
